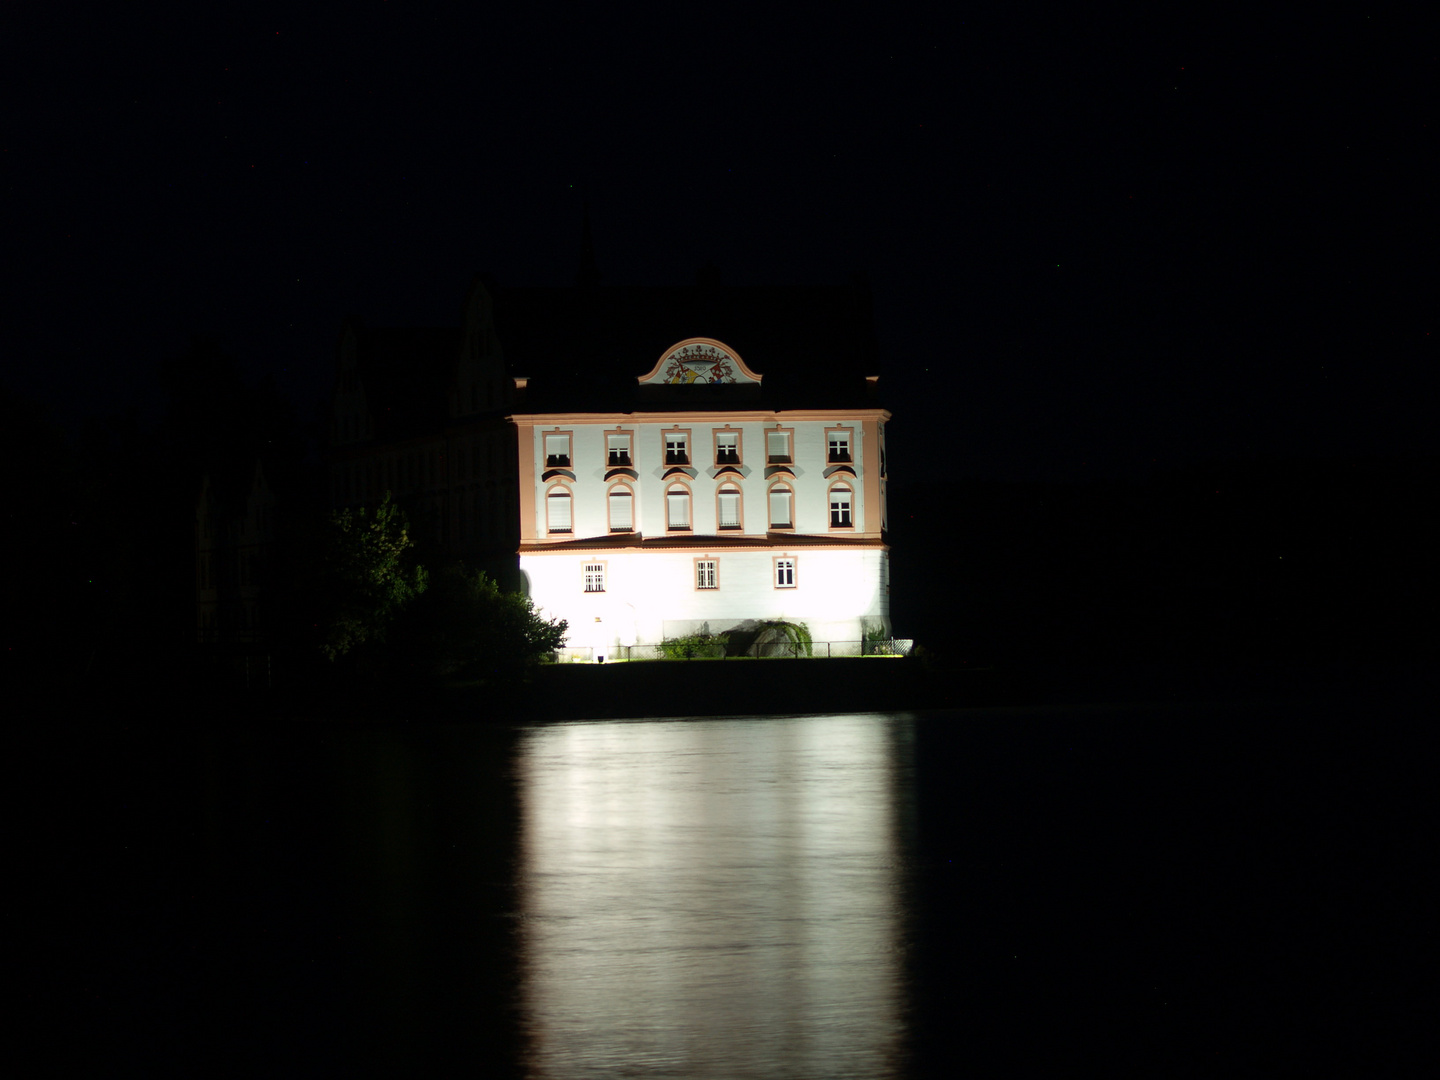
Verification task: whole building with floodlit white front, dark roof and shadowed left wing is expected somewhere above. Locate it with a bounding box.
[327,242,890,658]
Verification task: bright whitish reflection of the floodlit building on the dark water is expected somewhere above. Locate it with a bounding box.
[517,714,910,1077]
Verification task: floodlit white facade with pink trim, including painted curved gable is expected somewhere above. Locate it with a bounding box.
[511,341,890,657]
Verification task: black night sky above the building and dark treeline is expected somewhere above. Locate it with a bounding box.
[0,0,1437,480]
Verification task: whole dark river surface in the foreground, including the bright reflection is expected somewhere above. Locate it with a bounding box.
[42,701,1436,1077]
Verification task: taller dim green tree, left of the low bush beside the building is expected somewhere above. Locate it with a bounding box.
[317,492,428,660]
